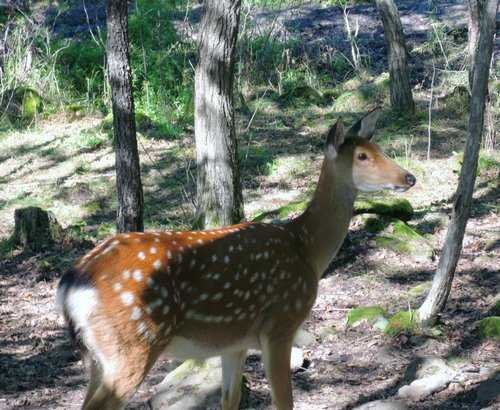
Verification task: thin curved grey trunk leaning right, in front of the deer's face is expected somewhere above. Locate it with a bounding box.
[419,0,498,323]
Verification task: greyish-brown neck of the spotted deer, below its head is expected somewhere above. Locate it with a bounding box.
[291,160,357,280]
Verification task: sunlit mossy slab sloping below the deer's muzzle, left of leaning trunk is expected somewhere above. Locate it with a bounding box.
[376,217,435,259]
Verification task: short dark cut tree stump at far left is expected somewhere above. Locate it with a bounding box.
[14,206,63,252]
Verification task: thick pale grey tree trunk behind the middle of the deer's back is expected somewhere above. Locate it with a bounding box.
[194,0,243,228]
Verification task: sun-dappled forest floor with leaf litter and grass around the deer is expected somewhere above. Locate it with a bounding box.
[0,2,500,410]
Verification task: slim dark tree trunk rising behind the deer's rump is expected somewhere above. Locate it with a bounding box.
[106,0,144,232]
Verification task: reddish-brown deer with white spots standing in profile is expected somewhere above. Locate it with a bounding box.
[57,107,416,410]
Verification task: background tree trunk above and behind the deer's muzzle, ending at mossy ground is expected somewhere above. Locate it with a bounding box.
[375,0,415,113]
